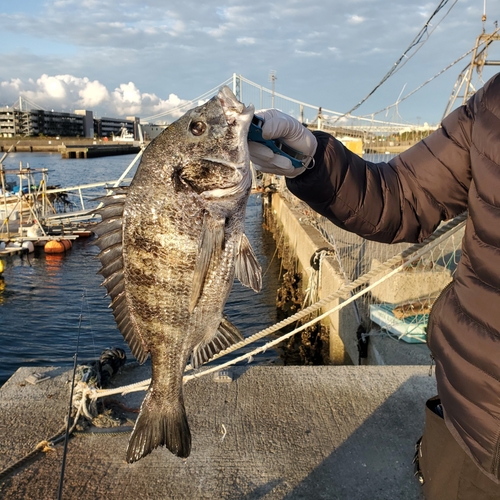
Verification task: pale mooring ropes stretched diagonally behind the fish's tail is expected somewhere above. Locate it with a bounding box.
[76,213,467,413]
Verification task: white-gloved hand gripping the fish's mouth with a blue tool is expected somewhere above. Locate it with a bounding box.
[248,109,318,177]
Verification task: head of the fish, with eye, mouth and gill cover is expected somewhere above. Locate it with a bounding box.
[156,86,255,200]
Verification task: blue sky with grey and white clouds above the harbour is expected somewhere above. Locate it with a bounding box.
[0,0,500,124]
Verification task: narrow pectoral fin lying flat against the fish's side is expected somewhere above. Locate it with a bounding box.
[189,215,225,312]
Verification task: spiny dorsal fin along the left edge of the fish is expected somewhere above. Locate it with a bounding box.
[93,188,148,363]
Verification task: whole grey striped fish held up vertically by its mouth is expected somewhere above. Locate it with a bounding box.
[94,86,262,463]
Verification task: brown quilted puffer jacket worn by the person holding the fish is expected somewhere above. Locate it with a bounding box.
[287,74,500,481]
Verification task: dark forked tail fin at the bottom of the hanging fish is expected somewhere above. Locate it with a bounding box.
[127,391,191,463]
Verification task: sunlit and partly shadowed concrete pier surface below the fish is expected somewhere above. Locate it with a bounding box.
[0,365,435,500]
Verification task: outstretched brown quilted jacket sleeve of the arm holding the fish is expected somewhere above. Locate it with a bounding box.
[286,94,476,243]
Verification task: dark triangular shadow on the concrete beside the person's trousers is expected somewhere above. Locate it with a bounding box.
[284,376,434,500]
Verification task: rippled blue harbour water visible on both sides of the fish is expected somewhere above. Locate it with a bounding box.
[0,153,279,385]
